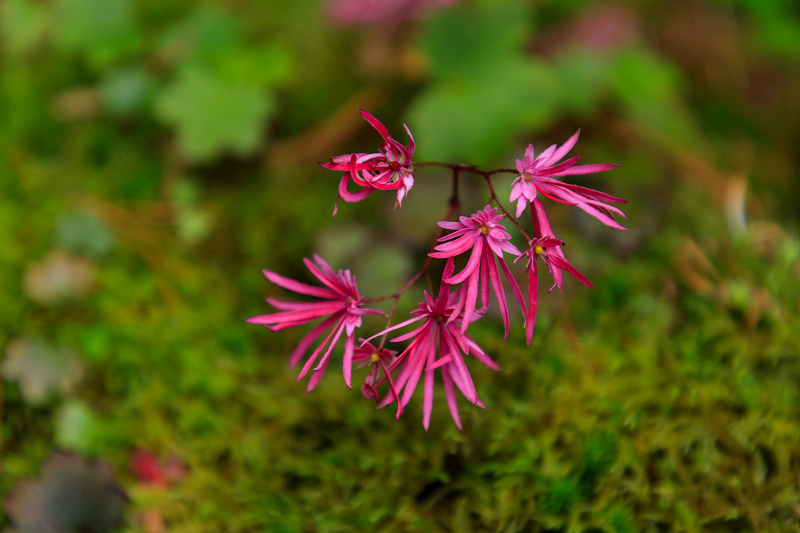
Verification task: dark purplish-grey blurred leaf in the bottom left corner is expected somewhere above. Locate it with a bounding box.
[5,453,127,533]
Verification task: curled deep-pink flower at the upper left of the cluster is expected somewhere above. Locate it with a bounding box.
[320,109,415,215]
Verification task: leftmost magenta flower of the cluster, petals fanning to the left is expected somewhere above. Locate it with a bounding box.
[247,255,382,391]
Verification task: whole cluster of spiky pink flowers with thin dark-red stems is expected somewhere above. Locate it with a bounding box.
[248,110,625,429]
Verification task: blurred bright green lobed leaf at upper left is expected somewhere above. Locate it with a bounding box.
[156,67,274,162]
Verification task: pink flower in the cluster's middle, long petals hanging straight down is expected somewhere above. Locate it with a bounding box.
[428,205,525,338]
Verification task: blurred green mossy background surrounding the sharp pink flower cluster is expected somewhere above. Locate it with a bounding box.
[0,0,800,533]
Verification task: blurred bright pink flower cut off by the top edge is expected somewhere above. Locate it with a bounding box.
[326,0,458,26]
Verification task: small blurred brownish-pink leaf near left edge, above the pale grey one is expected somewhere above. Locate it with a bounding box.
[25,250,97,304]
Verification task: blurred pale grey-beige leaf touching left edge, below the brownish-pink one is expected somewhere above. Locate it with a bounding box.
[0,338,83,404]
